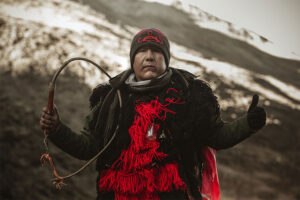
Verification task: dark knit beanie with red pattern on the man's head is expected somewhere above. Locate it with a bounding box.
[130,28,170,68]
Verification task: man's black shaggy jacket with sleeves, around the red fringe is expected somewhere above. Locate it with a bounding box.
[49,68,253,199]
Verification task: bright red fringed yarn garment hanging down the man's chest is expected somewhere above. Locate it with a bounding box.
[99,89,186,200]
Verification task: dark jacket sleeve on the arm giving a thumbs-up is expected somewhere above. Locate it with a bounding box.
[190,80,253,150]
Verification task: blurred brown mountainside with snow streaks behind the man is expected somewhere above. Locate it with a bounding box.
[0,0,300,200]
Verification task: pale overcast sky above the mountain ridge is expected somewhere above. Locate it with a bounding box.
[192,0,300,55]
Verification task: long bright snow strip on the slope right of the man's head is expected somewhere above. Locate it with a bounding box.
[173,45,300,110]
